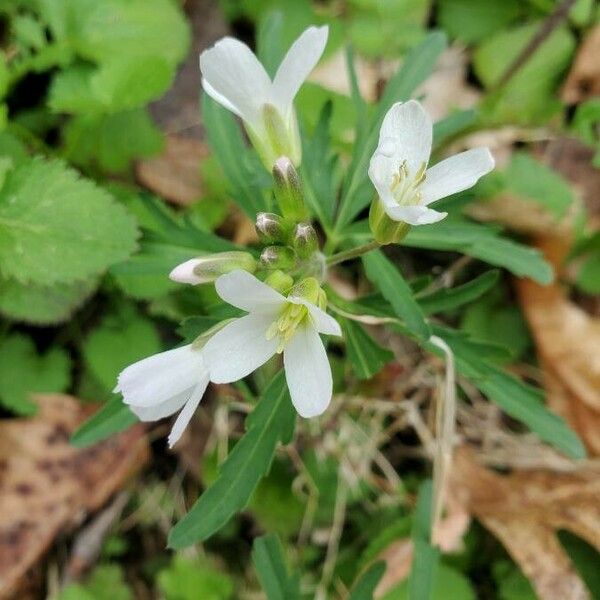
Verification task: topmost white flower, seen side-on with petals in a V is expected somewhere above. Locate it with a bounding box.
[200,27,328,170]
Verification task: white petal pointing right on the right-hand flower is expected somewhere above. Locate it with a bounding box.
[421,148,494,204]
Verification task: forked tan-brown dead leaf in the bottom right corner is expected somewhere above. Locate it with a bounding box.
[451,448,600,600]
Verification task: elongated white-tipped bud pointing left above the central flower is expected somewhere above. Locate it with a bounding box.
[169,251,257,285]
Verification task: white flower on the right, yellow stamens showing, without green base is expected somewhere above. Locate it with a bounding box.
[369,100,494,225]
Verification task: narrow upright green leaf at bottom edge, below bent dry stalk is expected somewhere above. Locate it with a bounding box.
[408,480,440,600]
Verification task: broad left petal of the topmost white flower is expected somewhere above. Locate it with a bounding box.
[200,37,272,125]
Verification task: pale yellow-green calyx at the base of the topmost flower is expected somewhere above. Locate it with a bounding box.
[246,103,302,171]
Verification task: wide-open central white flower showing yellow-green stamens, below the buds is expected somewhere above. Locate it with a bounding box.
[204,271,341,417]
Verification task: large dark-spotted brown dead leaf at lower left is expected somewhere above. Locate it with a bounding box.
[0,394,148,598]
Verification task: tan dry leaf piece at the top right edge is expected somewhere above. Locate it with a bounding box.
[562,25,600,104]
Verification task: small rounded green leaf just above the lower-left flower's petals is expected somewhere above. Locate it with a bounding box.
[82,305,161,390]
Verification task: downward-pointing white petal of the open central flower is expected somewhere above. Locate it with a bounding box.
[283,326,333,418]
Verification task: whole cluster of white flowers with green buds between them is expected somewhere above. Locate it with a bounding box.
[115,27,494,446]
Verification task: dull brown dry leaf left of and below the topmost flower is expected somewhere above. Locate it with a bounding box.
[135,135,208,206]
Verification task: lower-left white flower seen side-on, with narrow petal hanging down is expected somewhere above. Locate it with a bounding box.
[114,344,209,447]
